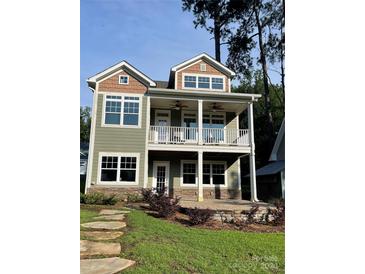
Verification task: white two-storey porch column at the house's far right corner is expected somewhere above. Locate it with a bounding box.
[248,102,258,202]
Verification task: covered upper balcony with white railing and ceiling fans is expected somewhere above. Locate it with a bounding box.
[147,89,256,153]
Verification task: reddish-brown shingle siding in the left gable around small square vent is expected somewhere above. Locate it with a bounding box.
[99,70,147,94]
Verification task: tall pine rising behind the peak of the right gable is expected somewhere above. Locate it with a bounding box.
[182,0,232,62]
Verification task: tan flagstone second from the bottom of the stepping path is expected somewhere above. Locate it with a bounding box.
[80,240,121,258]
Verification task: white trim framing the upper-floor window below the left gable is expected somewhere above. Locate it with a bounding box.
[101,92,143,128]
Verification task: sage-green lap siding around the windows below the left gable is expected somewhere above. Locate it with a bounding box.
[91,94,147,187]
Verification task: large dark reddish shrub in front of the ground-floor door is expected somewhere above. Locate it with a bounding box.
[142,189,180,218]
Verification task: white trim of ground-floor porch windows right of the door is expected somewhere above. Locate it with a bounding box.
[180,160,227,188]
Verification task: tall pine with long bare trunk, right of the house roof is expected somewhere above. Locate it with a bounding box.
[227,0,280,146]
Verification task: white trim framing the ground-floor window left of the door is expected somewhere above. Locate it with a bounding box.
[97,152,140,186]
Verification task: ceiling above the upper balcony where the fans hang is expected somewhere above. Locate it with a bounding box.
[151,98,247,114]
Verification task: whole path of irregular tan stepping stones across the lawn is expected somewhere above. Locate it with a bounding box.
[80,209,135,274]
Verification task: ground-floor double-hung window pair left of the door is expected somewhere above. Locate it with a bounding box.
[100,153,139,184]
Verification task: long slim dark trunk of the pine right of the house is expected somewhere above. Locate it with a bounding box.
[254,6,274,146]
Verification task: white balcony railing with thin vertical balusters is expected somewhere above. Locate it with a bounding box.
[148,126,249,146]
